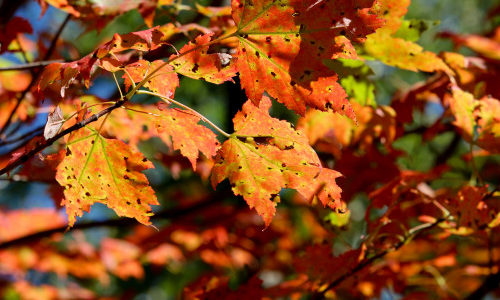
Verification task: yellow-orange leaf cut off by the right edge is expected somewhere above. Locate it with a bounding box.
[447,87,500,153]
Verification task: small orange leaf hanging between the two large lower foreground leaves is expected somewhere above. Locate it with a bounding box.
[156,109,220,170]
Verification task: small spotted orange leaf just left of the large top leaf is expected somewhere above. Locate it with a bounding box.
[170,34,237,84]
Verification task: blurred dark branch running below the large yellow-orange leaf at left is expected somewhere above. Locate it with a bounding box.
[0,197,217,249]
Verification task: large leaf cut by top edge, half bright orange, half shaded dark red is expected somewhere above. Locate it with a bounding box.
[232,0,381,117]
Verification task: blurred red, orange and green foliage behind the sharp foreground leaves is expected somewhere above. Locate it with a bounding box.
[0,0,500,299]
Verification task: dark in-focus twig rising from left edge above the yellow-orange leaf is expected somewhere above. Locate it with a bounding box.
[0,99,127,175]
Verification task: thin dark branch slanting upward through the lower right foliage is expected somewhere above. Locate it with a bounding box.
[311,218,446,299]
